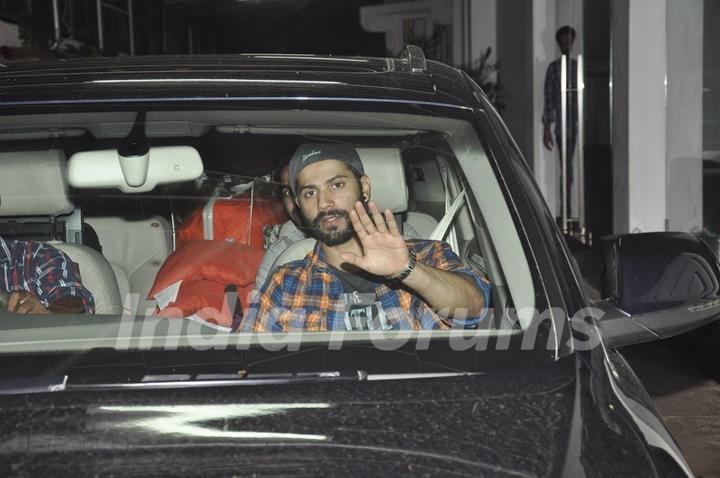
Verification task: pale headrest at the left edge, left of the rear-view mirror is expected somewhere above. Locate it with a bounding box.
[0,149,75,216]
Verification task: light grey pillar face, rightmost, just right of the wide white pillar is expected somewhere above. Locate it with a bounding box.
[667,0,703,232]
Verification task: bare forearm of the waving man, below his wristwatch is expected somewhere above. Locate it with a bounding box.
[403,263,485,318]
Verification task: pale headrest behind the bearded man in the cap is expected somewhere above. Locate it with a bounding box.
[357,148,408,213]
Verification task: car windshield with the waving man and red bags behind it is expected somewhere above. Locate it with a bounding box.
[0,104,536,362]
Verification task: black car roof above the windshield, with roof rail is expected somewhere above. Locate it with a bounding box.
[0,49,477,107]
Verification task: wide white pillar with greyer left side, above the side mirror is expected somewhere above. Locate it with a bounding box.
[611,0,672,233]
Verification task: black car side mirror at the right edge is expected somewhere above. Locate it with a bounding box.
[598,232,720,347]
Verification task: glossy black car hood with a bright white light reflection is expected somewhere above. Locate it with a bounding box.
[0,350,678,476]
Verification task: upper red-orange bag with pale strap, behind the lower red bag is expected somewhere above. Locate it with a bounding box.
[177,197,288,247]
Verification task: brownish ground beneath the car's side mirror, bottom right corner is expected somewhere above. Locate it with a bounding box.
[621,341,720,478]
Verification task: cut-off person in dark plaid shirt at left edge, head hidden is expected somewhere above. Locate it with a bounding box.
[0,237,95,314]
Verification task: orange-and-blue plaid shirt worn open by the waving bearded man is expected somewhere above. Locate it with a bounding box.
[240,241,490,332]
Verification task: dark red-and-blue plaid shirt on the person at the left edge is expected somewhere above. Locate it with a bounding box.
[0,237,95,314]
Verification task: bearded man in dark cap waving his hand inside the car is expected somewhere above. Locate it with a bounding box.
[241,144,490,332]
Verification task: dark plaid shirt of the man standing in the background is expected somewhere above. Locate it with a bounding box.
[542,58,578,137]
